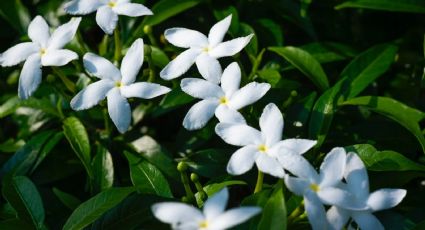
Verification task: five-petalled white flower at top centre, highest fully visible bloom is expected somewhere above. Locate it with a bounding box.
[160,15,254,83]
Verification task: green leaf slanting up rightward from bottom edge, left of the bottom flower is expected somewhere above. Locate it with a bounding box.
[63,187,134,230]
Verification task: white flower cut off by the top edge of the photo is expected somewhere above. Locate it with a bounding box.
[65,0,153,34]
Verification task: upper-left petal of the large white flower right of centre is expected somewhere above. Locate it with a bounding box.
[215,123,262,146]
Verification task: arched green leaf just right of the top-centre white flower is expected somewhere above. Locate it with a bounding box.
[269,46,329,91]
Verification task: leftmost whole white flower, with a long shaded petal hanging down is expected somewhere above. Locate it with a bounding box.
[0,16,81,99]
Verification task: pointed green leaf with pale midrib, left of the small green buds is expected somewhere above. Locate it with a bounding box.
[124,152,173,198]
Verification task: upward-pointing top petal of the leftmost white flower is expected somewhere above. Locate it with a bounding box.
[28,16,50,47]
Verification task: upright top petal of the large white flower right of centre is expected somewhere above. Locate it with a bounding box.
[260,103,283,146]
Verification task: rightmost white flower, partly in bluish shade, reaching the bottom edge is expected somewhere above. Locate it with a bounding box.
[327,153,406,230]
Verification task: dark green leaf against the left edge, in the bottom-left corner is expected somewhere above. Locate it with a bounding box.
[2,176,45,229]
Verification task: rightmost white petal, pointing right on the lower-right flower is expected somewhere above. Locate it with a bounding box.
[367,188,406,211]
